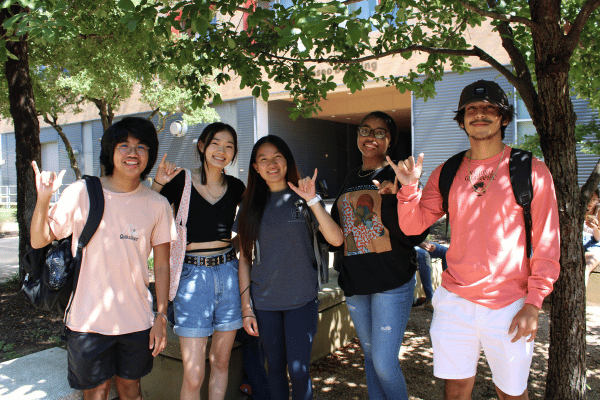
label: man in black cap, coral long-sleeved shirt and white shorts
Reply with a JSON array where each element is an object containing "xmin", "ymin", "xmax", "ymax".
[{"xmin": 388, "ymin": 80, "xmax": 560, "ymax": 400}]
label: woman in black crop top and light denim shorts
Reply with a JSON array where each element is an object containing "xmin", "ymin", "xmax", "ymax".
[{"xmin": 152, "ymin": 122, "xmax": 245, "ymax": 400}]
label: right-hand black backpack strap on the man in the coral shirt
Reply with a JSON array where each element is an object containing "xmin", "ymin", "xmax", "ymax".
[{"xmin": 508, "ymin": 148, "xmax": 533, "ymax": 258}]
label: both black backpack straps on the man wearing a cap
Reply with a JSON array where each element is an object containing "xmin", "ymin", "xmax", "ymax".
[{"xmin": 439, "ymin": 148, "xmax": 533, "ymax": 258}]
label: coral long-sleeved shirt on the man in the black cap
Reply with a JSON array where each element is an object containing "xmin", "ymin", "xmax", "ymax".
[{"xmin": 397, "ymin": 147, "xmax": 560, "ymax": 309}]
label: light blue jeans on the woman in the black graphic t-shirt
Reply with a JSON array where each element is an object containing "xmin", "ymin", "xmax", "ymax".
[{"xmin": 346, "ymin": 277, "xmax": 416, "ymax": 400}]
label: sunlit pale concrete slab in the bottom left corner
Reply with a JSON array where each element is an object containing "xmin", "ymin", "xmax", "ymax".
[{"xmin": 0, "ymin": 347, "xmax": 118, "ymax": 400}]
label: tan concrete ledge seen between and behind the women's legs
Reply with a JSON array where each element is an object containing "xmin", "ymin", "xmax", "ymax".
[{"xmin": 142, "ymin": 266, "xmax": 356, "ymax": 400}]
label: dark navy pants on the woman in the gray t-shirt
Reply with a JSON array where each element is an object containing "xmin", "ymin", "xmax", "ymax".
[{"xmin": 256, "ymin": 299, "xmax": 319, "ymax": 400}]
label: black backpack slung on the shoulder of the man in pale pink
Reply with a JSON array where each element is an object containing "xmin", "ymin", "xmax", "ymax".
[{"xmin": 21, "ymin": 175, "xmax": 104, "ymax": 320}]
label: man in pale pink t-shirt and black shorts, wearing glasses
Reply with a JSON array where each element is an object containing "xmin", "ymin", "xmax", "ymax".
[{"xmin": 31, "ymin": 117, "xmax": 177, "ymax": 400}]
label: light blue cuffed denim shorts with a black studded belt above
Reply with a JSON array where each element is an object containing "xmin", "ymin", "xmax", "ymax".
[{"xmin": 173, "ymin": 253, "xmax": 242, "ymax": 337}]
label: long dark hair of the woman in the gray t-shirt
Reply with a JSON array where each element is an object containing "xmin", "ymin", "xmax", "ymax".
[{"xmin": 238, "ymin": 135, "xmax": 300, "ymax": 260}]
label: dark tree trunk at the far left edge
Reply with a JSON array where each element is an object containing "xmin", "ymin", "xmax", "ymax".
[{"xmin": 0, "ymin": 6, "xmax": 41, "ymax": 279}]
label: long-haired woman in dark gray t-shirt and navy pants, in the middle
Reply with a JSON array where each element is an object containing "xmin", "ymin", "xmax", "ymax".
[{"xmin": 233, "ymin": 135, "xmax": 343, "ymax": 400}]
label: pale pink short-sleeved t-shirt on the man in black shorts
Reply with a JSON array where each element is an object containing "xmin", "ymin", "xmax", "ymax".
[{"xmin": 49, "ymin": 180, "xmax": 177, "ymax": 335}]
